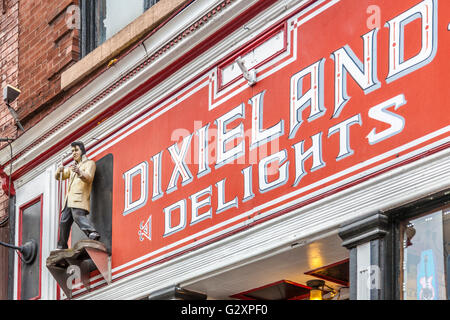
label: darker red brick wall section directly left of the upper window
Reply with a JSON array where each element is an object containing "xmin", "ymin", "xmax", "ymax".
[{"xmin": 17, "ymin": 0, "xmax": 80, "ymax": 129}]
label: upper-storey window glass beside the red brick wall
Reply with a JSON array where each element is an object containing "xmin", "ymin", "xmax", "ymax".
[{"xmin": 80, "ymin": 0, "xmax": 159, "ymax": 57}]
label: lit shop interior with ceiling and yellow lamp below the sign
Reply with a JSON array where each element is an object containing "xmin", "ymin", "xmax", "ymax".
[{"xmin": 180, "ymin": 234, "xmax": 349, "ymax": 300}]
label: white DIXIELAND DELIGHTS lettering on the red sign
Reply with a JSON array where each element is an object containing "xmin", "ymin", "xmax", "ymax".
[{"xmin": 118, "ymin": 0, "xmax": 437, "ymax": 237}]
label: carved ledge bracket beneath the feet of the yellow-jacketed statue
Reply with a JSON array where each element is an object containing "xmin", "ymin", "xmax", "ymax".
[{"xmin": 47, "ymin": 240, "xmax": 111, "ymax": 299}]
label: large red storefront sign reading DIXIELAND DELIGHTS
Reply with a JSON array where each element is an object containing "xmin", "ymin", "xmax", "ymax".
[{"xmin": 86, "ymin": 0, "xmax": 450, "ymax": 277}]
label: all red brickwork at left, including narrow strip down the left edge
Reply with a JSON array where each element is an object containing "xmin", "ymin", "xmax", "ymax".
[{"xmin": 0, "ymin": 0, "xmax": 80, "ymax": 299}]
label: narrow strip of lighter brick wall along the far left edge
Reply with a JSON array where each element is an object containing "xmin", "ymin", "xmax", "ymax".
[{"xmin": 0, "ymin": 0, "xmax": 19, "ymax": 300}]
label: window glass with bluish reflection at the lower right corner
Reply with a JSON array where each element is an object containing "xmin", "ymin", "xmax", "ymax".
[{"xmin": 401, "ymin": 208, "xmax": 450, "ymax": 300}]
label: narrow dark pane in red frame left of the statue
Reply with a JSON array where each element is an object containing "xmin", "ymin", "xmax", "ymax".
[{"xmin": 20, "ymin": 201, "xmax": 41, "ymax": 300}]
